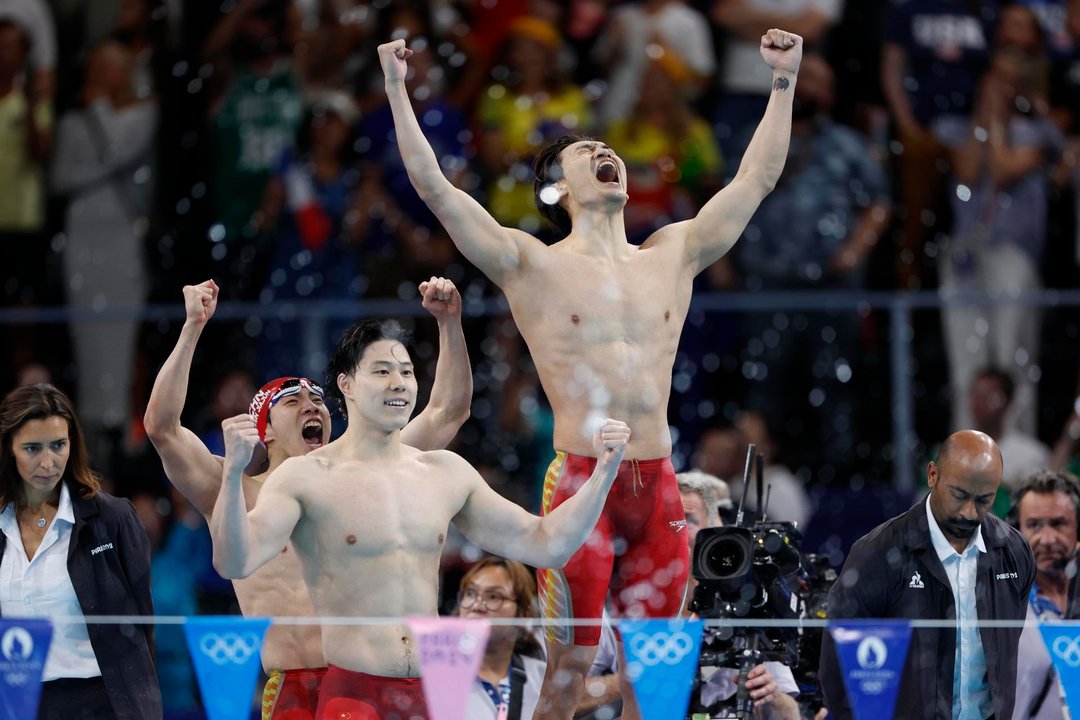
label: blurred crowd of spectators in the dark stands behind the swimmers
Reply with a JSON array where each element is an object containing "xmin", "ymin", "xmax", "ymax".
[{"xmin": 0, "ymin": 0, "xmax": 1080, "ymax": 716}]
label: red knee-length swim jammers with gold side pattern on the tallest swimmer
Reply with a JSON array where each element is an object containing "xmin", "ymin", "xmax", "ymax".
[{"xmin": 537, "ymin": 452, "xmax": 690, "ymax": 646}]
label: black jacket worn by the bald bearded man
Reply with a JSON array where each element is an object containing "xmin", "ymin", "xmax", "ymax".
[{"xmin": 820, "ymin": 501, "xmax": 1036, "ymax": 720}]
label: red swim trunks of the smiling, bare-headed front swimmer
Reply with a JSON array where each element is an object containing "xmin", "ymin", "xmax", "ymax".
[{"xmin": 315, "ymin": 665, "xmax": 428, "ymax": 720}]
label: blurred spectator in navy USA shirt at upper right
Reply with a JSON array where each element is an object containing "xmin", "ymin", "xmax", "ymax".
[{"xmin": 881, "ymin": 0, "xmax": 996, "ymax": 289}]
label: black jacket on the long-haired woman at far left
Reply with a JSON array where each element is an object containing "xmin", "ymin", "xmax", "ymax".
[{"xmin": 0, "ymin": 484, "xmax": 162, "ymax": 720}]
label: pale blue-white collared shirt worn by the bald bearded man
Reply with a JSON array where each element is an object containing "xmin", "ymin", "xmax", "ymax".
[{"xmin": 927, "ymin": 497, "xmax": 994, "ymax": 720}]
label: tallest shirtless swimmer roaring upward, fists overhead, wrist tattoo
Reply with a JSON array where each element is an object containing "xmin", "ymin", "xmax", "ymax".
[{"xmin": 378, "ymin": 29, "xmax": 802, "ymax": 719}]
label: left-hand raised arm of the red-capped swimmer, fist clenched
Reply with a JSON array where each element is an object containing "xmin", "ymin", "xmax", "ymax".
[{"xmin": 143, "ymin": 280, "xmax": 221, "ymax": 516}]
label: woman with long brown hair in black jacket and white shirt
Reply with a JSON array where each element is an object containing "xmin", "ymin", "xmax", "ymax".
[{"xmin": 0, "ymin": 384, "xmax": 162, "ymax": 720}]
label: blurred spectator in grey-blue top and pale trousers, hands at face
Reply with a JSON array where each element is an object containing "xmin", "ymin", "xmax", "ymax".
[{"xmin": 934, "ymin": 38, "xmax": 1063, "ymax": 434}]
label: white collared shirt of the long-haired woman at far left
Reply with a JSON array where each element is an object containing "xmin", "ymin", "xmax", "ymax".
[{"xmin": 0, "ymin": 483, "xmax": 102, "ymax": 681}]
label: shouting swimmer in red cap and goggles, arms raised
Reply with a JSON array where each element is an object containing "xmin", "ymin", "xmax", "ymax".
[{"xmin": 145, "ymin": 277, "xmax": 472, "ymax": 720}]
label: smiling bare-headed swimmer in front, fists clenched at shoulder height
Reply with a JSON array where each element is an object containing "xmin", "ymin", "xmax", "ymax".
[{"xmin": 211, "ymin": 321, "xmax": 630, "ymax": 719}]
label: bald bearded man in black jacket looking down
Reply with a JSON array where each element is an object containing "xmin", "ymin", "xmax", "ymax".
[{"xmin": 820, "ymin": 430, "xmax": 1036, "ymax": 720}]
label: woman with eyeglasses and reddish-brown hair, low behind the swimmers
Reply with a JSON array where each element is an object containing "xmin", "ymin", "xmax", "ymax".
[{"xmin": 458, "ymin": 557, "xmax": 546, "ymax": 720}]
